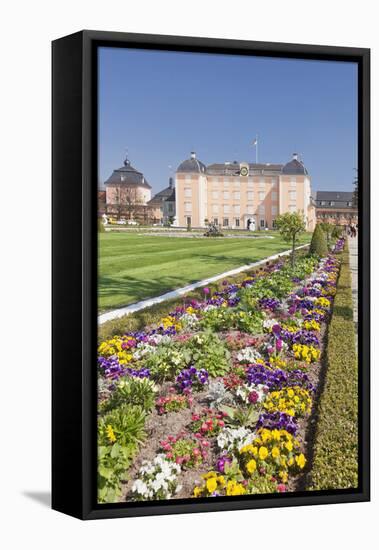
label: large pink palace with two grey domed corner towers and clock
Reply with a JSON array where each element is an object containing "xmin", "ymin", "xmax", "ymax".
[{"xmin": 175, "ymin": 152, "xmax": 316, "ymax": 231}]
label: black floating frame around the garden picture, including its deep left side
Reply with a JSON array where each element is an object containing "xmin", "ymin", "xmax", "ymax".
[{"xmin": 52, "ymin": 31, "xmax": 370, "ymax": 519}]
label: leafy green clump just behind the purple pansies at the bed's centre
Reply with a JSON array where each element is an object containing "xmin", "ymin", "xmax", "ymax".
[{"xmin": 183, "ymin": 330, "xmax": 231, "ymax": 377}]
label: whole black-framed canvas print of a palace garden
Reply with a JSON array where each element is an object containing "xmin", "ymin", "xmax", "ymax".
[{"xmin": 52, "ymin": 31, "xmax": 370, "ymax": 519}]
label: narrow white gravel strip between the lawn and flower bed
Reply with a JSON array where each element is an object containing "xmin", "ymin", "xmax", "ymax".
[{"xmin": 97, "ymin": 244, "xmax": 309, "ymax": 325}]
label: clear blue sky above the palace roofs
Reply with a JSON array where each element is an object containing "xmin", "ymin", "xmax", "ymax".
[{"xmin": 99, "ymin": 48, "xmax": 357, "ymax": 193}]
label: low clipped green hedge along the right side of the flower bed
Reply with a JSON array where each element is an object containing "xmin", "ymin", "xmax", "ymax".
[{"xmin": 307, "ymin": 241, "xmax": 358, "ymax": 490}]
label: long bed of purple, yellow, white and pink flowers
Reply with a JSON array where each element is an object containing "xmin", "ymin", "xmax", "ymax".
[{"xmin": 98, "ymin": 242, "xmax": 341, "ymax": 502}]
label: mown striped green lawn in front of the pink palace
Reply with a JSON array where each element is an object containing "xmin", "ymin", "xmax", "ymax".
[{"xmin": 99, "ymin": 233, "xmax": 311, "ymax": 311}]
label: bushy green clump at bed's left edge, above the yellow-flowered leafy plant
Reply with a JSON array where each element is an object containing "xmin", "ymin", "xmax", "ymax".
[{"xmin": 101, "ymin": 376, "xmax": 157, "ymax": 413}]
